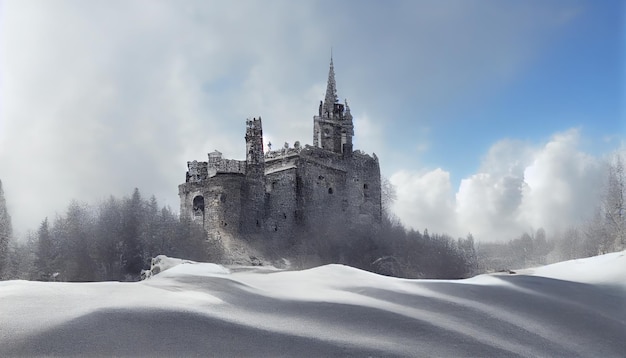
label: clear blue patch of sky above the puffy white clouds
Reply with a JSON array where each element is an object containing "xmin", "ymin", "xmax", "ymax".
[{"xmin": 376, "ymin": 2, "xmax": 625, "ymax": 181}]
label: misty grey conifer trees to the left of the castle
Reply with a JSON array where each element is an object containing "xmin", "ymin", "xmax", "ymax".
[{"xmin": 0, "ymin": 189, "xmax": 221, "ymax": 281}]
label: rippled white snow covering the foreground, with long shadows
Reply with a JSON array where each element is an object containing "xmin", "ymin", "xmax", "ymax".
[{"xmin": 0, "ymin": 252, "xmax": 626, "ymax": 357}]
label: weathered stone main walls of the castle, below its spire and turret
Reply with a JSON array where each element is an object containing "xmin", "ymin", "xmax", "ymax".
[{"xmin": 179, "ymin": 146, "xmax": 382, "ymax": 249}]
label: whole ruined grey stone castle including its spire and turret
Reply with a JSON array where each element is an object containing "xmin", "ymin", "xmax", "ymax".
[{"xmin": 178, "ymin": 57, "xmax": 381, "ymax": 248}]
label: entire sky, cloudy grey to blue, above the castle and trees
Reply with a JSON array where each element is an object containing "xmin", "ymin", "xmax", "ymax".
[{"xmin": 0, "ymin": 0, "xmax": 626, "ymax": 240}]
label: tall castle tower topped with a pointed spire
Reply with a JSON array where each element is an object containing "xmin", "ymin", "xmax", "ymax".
[{"xmin": 313, "ymin": 56, "xmax": 354, "ymax": 156}]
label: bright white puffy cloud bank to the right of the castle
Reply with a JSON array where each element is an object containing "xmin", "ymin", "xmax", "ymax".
[{"xmin": 390, "ymin": 129, "xmax": 606, "ymax": 241}]
